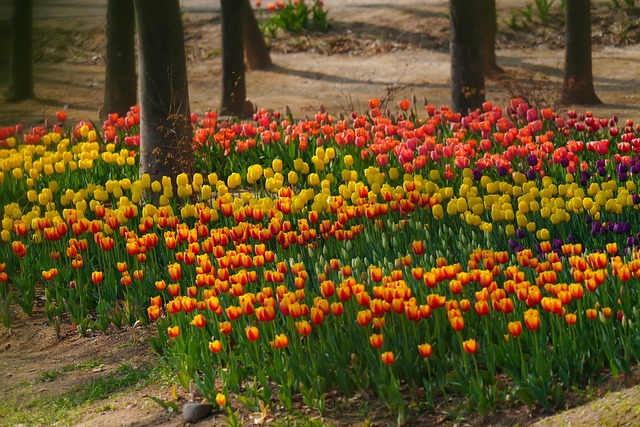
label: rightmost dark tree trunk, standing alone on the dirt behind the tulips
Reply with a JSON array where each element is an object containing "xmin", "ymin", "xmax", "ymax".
[{"xmin": 562, "ymin": 0, "xmax": 601, "ymax": 104}]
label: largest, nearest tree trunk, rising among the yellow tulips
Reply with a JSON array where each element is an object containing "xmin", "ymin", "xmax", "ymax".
[{"xmin": 134, "ymin": 0, "xmax": 194, "ymax": 187}]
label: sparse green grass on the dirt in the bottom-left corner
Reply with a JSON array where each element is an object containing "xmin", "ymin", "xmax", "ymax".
[{"xmin": 0, "ymin": 363, "xmax": 154, "ymax": 427}]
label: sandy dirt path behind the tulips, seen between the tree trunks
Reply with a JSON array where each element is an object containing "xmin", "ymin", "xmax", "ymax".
[{"xmin": 0, "ymin": 0, "xmax": 640, "ymax": 125}]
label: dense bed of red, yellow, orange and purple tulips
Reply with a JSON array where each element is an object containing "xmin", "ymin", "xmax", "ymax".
[{"xmin": 0, "ymin": 99, "xmax": 640, "ymax": 420}]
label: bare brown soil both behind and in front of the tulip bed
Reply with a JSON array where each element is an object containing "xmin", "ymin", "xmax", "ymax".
[{"xmin": 0, "ymin": 0, "xmax": 640, "ymax": 427}]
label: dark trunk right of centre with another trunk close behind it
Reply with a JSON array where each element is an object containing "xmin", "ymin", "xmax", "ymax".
[{"xmin": 449, "ymin": 0, "xmax": 485, "ymax": 114}]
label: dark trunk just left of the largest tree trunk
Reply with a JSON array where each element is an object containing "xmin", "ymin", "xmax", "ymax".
[{"xmin": 102, "ymin": 0, "xmax": 137, "ymax": 117}]
